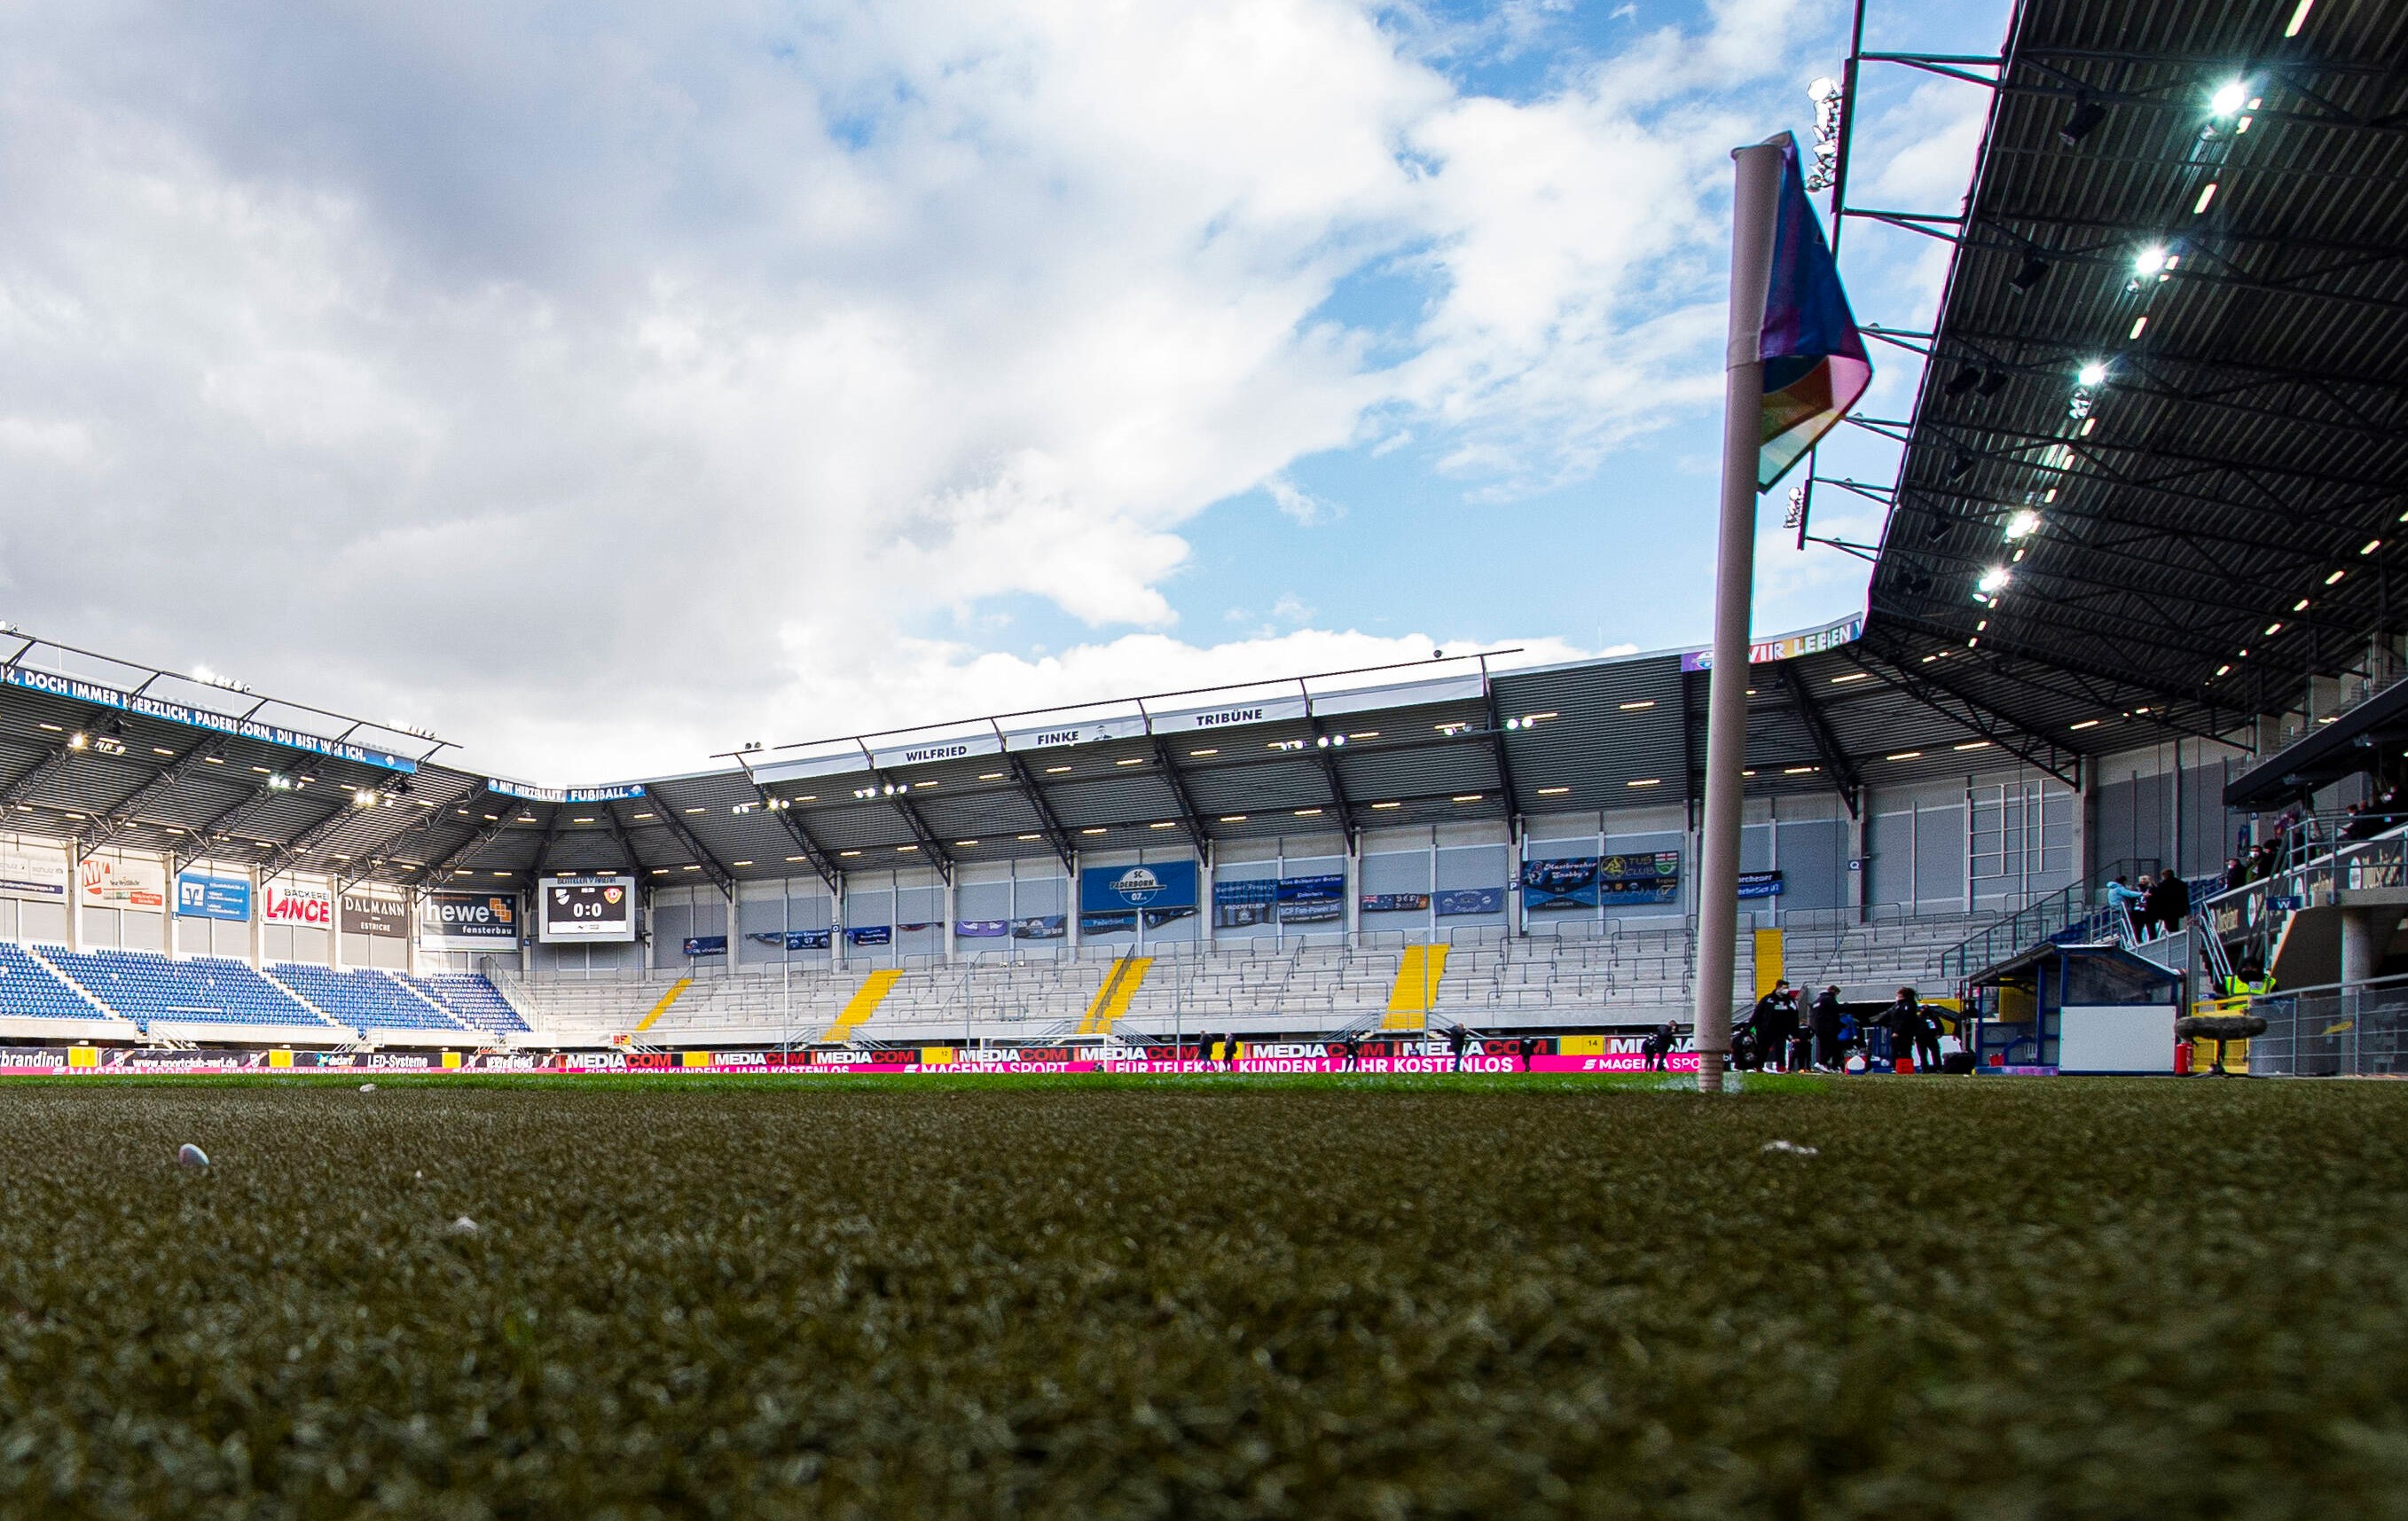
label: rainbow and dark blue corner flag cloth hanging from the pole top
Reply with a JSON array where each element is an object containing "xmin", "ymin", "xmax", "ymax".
[{"xmin": 1755, "ymin": 132, "xmax": 1873, "ymax": 491}]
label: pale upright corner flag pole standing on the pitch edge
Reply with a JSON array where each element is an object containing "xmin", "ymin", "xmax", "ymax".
[{"xmin": 1693, "ymin": 139, "xmax": 1782, "ymax": 1093}]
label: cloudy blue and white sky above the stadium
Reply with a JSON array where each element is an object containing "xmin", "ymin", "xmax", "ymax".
[{"xmin": 0, "ymin": 0, "xmax": 2006, "ymax": 785}]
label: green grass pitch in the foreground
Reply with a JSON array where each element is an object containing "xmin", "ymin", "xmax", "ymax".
[{"xmin": 0, "ymin": 1078, "xmax": 2408, "ymax": 1521}]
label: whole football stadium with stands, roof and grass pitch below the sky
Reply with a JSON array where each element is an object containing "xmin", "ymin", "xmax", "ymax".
[{"xmin": 0, "ymin": 0, "xmax": 2408, "ymax": 1518}]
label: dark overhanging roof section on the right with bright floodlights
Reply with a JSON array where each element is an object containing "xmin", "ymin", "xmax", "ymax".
[{"xmin": 1849, "ymin": 0, "xmax": 2408, "ymax": 753}]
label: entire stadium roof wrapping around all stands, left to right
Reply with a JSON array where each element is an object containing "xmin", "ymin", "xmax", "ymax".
[{"xmin": 0, "ymin": 0, "xmax": 2408, "ymax": 888}]
